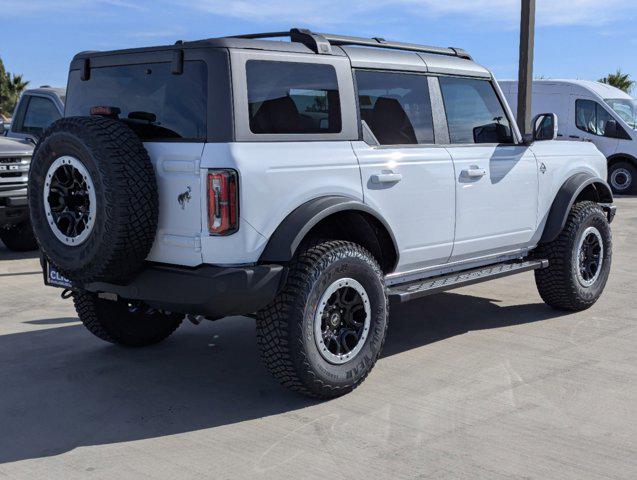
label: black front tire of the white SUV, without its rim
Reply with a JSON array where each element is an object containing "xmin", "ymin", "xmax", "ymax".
[{"xmin": 535, "ymin": 201, "xmax": 613, "ymax": 312}]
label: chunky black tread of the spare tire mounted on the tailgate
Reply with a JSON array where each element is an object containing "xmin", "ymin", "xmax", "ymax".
[{"xmin": 30, "ymin": 117, "xmax": 159, "ymax": 282}]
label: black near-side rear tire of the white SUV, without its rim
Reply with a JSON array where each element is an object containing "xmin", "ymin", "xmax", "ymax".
[{"xmin": 257, "ymin": 241, "xmax": 389, "ymax": 399}]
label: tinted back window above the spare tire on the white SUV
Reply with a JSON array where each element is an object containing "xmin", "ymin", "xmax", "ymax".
[{"xmin": 65, "ymin": 61, "xmax": 207, "ymax": 140}]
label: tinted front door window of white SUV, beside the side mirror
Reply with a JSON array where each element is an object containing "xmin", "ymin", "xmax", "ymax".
[{"xmin": 440, "ymin": 77, "xmax": 513, "ymax": 143}]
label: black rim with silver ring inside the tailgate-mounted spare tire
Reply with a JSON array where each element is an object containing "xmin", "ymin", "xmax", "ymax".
[{"xmin": 43, "ymin": 155, "xmax": 97, "ymax": 246}]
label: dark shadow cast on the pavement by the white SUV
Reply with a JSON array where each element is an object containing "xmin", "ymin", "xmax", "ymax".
[{"xmin": 0, "ymin": 293, "xmax": 559, "ymax": 463}]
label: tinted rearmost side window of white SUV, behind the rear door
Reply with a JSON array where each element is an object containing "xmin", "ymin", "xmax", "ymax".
[{"xmin": 246, "ymin": 60, "xmax": 341, "ymax": 134}]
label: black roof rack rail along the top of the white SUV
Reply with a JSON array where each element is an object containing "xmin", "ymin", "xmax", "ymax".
[{"xmin": 228, "ymin": 28, "xmax": 472, "ymax": 60}]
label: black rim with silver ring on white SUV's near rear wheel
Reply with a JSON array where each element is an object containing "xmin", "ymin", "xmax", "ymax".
[{"xmin": 314, "ymin": 278, "xmax": 372, "ymax": 365}]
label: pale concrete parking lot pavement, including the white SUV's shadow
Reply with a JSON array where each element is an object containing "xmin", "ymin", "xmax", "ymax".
[{"xmin": 0, "ymin": 198, "xmax": 637, "ymax": 480}]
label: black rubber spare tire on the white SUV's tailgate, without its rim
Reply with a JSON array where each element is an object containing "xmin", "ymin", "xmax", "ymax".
[{"xmin": 29, "ymin": 117, "xmax": 159, "ymax": 283}]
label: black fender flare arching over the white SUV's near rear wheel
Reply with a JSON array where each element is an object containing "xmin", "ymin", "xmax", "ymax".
[{"xmin": 259, "ymin": 195, "xmax": 399, "ymax": 263}]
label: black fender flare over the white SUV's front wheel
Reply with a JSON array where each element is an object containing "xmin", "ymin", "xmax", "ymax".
[{"xmin": 540, "ymin": 172, "xmax": 613, "ymax": 243}]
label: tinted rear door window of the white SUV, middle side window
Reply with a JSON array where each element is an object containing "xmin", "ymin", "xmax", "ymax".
[{"xmin": 356, "ymin": 71, "xmax": 434, "ymax": 145}]
